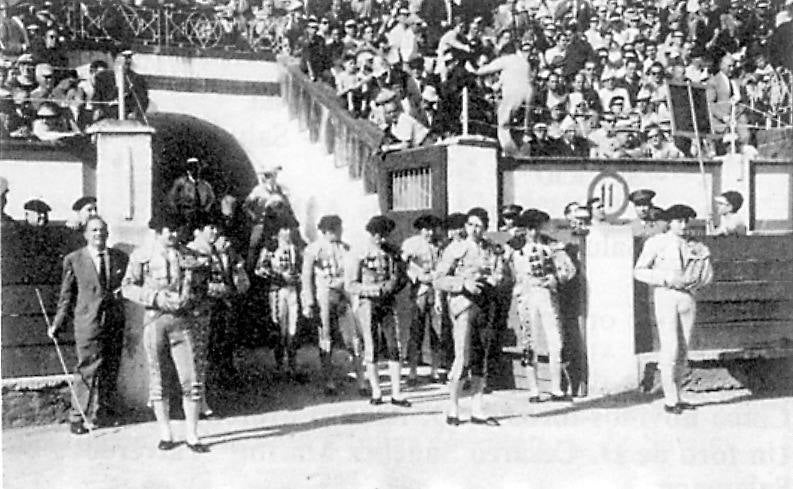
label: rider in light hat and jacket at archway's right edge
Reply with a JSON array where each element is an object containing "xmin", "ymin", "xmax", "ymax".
[{"xmin": 242, "ymin": 164, "xmax": 298, "ymax": 270}]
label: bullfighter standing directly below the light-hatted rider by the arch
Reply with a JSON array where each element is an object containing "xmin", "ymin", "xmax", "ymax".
[{"xmin": 255, "ymin": 215, "xmax": 303, "ymax": 380}]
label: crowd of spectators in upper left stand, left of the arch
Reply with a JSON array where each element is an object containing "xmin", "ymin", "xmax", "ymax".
[{"xmin": 0, "ymin": 2, "xmax": 148, "ymax": 141}]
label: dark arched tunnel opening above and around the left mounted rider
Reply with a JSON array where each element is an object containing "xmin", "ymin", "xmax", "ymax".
[{"xmin": 147, "ymin": 112, "xmax": 256, "ymax": 212}]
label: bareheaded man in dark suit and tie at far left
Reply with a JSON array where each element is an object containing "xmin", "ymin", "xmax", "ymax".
[{"xmin": 47, "ymin": 216, "xmax": 127, "ymax": 435}]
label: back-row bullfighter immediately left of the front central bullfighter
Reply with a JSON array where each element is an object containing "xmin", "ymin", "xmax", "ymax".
[{"xmin": 402, "ymin": 214, "xmax": 443, "ymax": 385}]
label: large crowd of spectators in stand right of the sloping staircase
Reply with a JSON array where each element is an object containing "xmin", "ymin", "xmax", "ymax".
[{"xmin": 283, "ymin": 0, "xmax": 793, "ymax": 158}]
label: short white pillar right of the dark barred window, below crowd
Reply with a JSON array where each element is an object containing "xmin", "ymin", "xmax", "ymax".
[{"xmin": 446, "ymin": 139, "xmax": 499, "ymax": 230}]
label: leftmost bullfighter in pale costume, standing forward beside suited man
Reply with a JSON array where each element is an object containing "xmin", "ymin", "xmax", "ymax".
[{"xmin": 121, "ymin": 215, "xmax": 209, "ymax": 453}]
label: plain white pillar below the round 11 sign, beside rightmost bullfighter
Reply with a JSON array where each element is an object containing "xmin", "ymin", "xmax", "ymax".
[{"xmin": 586, "ymin": 226, "xmax": 638, "ymax": 397}]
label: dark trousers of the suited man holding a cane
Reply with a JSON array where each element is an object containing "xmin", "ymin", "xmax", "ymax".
[{"xmin": 69, "ymin": 325, "xmax": 123, "ymax": 423}]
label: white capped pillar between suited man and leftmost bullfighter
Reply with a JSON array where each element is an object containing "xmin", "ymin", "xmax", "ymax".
[{"xmin": 88, "ymin": 119, "xmax": 154, "ymax": 409}]
